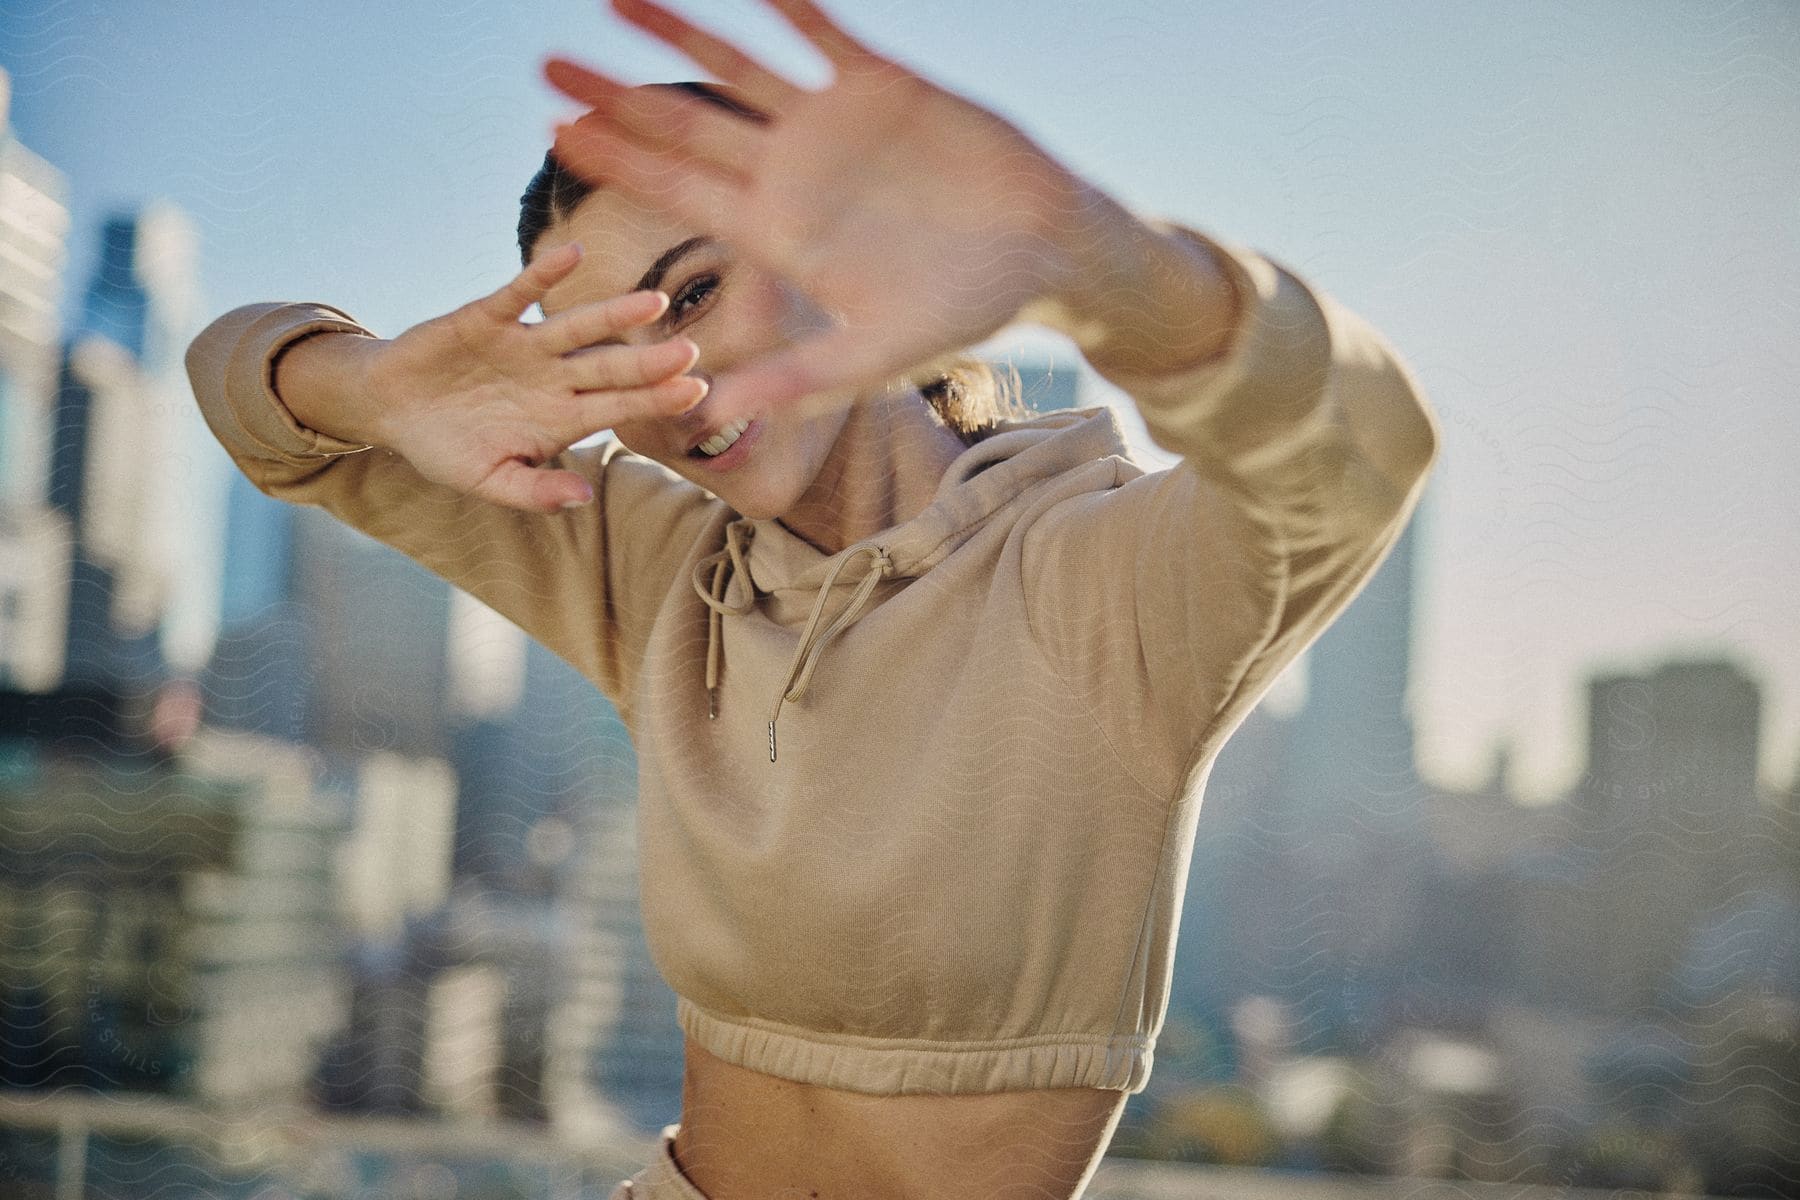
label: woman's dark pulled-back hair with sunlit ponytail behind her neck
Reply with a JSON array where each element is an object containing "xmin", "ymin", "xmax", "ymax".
[{"xmin": 518, "ymin": 81, "xmax": 1033, "ymax": 446}]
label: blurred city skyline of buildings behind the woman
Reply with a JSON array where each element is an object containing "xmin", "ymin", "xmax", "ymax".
[{"xmin": 0, "ymin": 21, "xmax": 1800, "ymax": 1200}]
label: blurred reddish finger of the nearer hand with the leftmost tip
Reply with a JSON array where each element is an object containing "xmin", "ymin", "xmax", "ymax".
[{"xmin": 544, "ymin": 58, "xmax": 767, "ymax": 178}]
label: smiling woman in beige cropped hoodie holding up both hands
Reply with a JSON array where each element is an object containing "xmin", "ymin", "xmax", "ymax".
[{"xmin": 189, "ymin": 0, "xmax": 1436, "ymax": 1200}]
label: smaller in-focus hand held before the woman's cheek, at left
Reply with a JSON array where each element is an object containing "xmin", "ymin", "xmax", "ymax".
[{"xmin": 338, "ymin": 245, "xmax": 706, "ymax": 513}]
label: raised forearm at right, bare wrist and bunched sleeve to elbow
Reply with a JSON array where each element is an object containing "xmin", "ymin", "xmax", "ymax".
[{"xmin": 1022, "ymin": 180, "xmax": 1438, "ymax": 495}]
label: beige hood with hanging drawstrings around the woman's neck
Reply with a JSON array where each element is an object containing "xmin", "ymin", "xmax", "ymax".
[{"xmin": 693, "ymin": 407, "xmax": 1130, "ymax": 761}]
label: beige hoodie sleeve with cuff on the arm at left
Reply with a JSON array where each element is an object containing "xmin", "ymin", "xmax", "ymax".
[{"xmin": 187, "ymin": 304, "xmax": 716, "ymax": 709}]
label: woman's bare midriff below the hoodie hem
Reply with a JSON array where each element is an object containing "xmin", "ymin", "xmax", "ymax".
[{"xmin": 675, "ymin": 1042, "xmax": 1127, "ymax": 1200}]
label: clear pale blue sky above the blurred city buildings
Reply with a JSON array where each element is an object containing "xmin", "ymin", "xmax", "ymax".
[{"xmin": 0, "ymin": 0, "xmax": 1800, "ymax": 795}]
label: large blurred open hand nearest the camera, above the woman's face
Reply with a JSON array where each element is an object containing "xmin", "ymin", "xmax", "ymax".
[{"xmin": 545, "ymin": 0, "xmax": 1096, "ymax": 426}]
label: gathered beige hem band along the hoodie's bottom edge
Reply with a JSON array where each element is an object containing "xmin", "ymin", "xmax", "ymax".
[{"xmin": 675, "ymin": 997, "xmax": 1154, "ymax": 1096}]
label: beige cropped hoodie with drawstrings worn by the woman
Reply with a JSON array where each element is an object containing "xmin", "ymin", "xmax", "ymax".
[{"xmin": 187, "ymin": 223, "xmax": 1438, "ymax": 1094}]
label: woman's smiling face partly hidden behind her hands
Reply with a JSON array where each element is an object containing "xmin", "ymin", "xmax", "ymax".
[{"xmin": 533, "ymin": 189, "xmax": 850, "ymax": 520}]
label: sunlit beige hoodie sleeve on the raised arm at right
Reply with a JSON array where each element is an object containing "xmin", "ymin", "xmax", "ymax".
[{"xmin": 1021, "ymin": 223, "xmax": 1438, "ymax": 793}]
